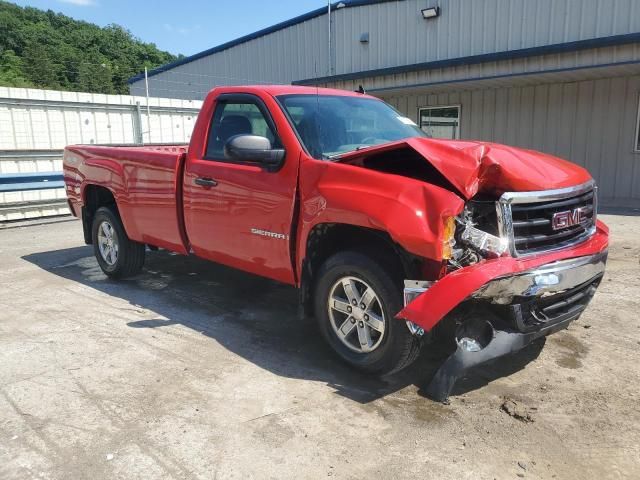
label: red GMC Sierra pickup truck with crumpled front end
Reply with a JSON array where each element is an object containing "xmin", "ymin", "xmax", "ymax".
[{"xmin": 64, "ymin": 86, "xmax": 608, "ymax": 400}]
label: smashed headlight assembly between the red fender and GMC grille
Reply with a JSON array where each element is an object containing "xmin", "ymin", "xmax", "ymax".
[{"xmin": 450, "ymin": 199, "xmax": 508, "ymax": 268}]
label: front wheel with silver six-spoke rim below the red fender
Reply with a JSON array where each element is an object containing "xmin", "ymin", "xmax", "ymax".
[{"xmin": 314, "ymin": 252, "xmax": 420, "ymax": 375}]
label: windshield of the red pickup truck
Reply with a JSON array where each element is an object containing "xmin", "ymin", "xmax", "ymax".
[{"xmin": 278, "ymin": 95, "xmax": 427, "ymax": 159}]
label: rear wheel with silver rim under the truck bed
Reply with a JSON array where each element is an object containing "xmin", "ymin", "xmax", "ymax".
[{"xmin": 91, "ymin": 207, "xmax": 145, "ymax": 278}]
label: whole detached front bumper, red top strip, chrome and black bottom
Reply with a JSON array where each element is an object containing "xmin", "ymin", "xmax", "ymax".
[{"xmin": 398, "ymin": 222, "xmax": 608, "ymax": 401}]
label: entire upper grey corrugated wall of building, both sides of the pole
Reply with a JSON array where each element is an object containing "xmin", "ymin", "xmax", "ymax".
[{"xmin": 131, "ymin": 0, "xmax": 640, "ymax": 99}]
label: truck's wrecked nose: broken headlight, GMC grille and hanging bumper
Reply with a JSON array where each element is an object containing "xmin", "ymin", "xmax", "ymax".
[{"xmin": 398, "ymin": 183, "xmax": 608, "ymax": 401}]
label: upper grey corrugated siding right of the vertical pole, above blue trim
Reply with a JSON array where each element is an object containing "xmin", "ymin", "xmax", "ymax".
[{"xmin": 334, "ymin": 0, "xmax": 640, "ymax": 74}]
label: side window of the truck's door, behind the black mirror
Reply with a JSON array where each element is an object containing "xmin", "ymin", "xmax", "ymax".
[{"xmin": 206, "ymin": 102, "xmax": 279, "ymax": 159}]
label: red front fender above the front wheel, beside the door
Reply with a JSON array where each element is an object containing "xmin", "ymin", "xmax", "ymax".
[{"xmin": 298, "ymin": 160, "xmax": 464, "ymax": 265}]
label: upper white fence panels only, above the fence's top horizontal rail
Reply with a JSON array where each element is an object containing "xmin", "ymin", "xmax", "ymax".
[{"xmin": 0, "ymin": 87, "xmax": 202, "ymax": 150}]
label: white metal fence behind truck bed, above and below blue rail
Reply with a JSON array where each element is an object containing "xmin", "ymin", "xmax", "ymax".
[{"xmin": 0, "ymin": 87, "xmax": 202, "ymax": 221}]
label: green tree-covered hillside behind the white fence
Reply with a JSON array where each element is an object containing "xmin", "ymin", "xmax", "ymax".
[{"xmin": 0, "ymin": 0, "xmax": 178, "ymax": 94}]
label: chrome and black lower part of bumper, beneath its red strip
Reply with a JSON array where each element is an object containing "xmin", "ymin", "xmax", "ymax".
[{"xmin": 426, "ymin": 250, "xmax": 607, "ymax": 401}]
